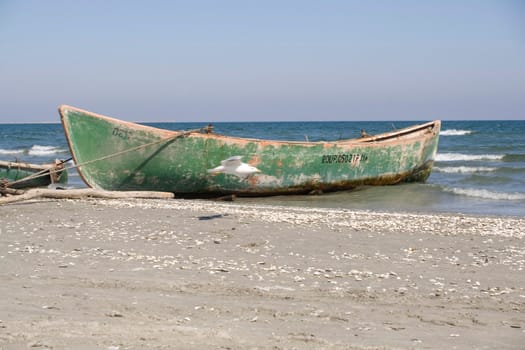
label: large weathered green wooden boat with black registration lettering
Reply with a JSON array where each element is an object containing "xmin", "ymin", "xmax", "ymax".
[{"xmin": 59, "ymin": 105, "xmax": 441, "ymax": 196}]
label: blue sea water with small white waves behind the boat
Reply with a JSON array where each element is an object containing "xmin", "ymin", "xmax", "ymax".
[{"xmin": 0, "ymin": 121, "xmax": 525, "ymax": 217}]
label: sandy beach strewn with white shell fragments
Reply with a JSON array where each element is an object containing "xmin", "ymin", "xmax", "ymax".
[{"xmin": 0, "ymin": 199, "xmax": 525, "ymax": 350}]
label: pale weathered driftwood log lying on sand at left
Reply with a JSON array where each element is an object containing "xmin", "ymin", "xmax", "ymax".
[{"xmin": 0, "ymin": 188, "xmax": 175, "ymax": 205}]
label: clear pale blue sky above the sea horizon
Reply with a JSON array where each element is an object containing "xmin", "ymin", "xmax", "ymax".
[{"xmin": 0, "ymin": 0, "xmax": 525, "ymax": 122}]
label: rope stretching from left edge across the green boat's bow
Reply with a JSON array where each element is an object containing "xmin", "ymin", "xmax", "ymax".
[{"xmin": 0, "ymin": 124, "xmax": 213, "ymax": 188}]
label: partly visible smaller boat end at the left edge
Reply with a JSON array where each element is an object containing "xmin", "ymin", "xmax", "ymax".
[{"xmin": 0, "ymin": 160, "xmax": 68, "ymax": 189}]
